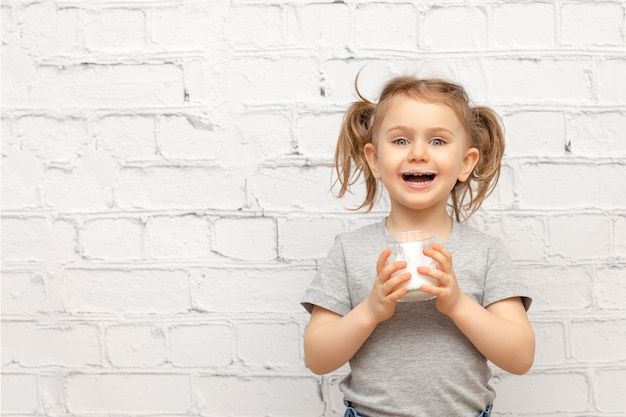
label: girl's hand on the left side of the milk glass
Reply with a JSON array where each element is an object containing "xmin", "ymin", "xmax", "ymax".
[{"xmin": 364, "ymin": 248, "xmax": 411, "ymax": 323}]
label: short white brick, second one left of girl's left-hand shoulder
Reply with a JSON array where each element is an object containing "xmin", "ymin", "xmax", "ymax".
[{"xmin": 213, "ymin": 218, "xmax": 277, "ymax": 261}]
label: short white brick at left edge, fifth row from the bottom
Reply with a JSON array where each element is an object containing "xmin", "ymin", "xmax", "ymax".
[{"xmin": 2, "ymin": 151, "xmax": 44, "ymax": 209}]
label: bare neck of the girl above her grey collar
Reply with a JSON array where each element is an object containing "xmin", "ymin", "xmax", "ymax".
[{"xmin": 385, "ymin": 203, "xmax": 452, "ymax": 242}]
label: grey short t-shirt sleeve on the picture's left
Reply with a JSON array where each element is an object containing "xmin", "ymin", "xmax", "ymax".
[{"xmin": 301, "ymin": 237, "xmax": 352, "ymax": 316}]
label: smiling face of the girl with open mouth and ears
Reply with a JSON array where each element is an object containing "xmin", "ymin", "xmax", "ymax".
[{"xmin": 365, "ymin": 96, "xmax": 478, "ymax": 216}]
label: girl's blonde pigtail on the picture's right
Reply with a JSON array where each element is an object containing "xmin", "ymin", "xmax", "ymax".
[{"xmin": 452, "ymin": 106, "xmax": 505, "ymax": 221}]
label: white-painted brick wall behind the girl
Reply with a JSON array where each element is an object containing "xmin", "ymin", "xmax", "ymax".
[{"xmin": 1, "ymin": 0, "xmax": 626, "ymax": 417}]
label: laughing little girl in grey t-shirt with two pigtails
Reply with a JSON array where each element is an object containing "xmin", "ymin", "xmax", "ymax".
[{"xmin": 302, "ymin": 77, "xmax": 535, "ymax": 417}]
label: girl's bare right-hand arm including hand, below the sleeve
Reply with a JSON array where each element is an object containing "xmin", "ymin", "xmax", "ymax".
[{"xmin": 418, "ymin": 240, "xmax": 535, "ymax": 374}]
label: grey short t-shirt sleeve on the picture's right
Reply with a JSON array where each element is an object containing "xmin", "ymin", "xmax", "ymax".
[{"xmin": 482, "ymin": 239, "xmax": 532, "ymax": 311}]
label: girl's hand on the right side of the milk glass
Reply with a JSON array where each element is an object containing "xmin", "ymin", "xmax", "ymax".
[{"xmin": 417, "ymin": 243, "xmax": 463, "ymax": 315}]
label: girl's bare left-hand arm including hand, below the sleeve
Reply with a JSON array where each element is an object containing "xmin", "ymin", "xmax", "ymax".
[{"xmin": 304, "ymin": 249, "xmax": 411, "ymax": 375}]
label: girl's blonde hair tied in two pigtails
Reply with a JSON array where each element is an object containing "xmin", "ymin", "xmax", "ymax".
[{"xmin": 333, "ymin": 75, "xmax": 504, "ymax": 221}]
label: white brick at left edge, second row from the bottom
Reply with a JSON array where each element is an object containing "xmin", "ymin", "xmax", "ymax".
[{"xmin": 2, "ymin": 321, "xmax": 102, "ymax": 367}]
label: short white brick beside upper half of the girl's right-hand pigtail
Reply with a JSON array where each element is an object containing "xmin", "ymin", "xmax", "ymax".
[{"xmin": 503, "ymin": 111, "xmax": 571, "ymax": 157}]
